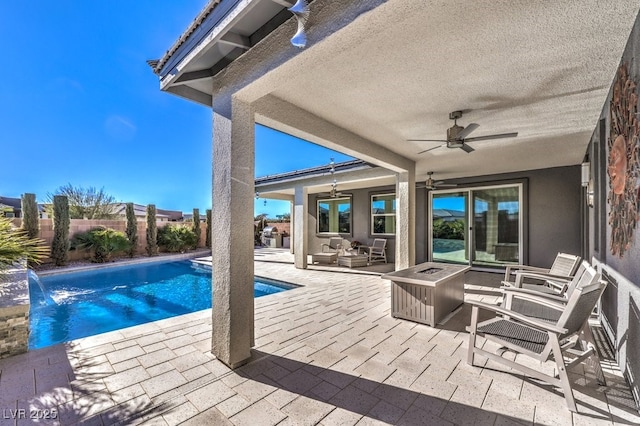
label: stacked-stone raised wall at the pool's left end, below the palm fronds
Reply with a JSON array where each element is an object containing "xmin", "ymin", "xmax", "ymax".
[{"xmin": 0, "ymin": 268, "xmax": 29, "ymax": 359}]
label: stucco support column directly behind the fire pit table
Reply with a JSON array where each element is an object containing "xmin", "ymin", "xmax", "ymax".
[{"xmin": 396, "ymin": 169, "xmax": 416, "ymax": 270}]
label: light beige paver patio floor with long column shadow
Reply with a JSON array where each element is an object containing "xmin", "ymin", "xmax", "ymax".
[{"xmin": 0, "ymin": 255, "xmax": 640, "ymax": 425}]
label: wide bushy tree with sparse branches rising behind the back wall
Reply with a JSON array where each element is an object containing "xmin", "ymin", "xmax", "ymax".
[{"xmin": 48, "ymin": 183, "xmax": 116, "ymax": 219}]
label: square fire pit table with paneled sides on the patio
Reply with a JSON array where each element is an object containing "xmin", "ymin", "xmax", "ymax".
[{"xmin": 382, "ymin": 262, "xmax": 471, "ymax": 327}]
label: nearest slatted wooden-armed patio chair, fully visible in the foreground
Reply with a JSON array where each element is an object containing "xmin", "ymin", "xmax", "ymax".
[{"xmin": 467, "ymin": 268, "xmax": 607, "ymax": 412}]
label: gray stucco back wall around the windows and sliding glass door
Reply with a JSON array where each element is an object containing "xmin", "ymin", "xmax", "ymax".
[{"xmin": 307, "ymin": 165, "xmax": 582, "ymax": 267}]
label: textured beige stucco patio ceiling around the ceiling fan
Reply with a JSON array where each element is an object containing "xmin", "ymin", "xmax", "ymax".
[{"xmin": 156, "ymin": 0, "xmax": 639, "ymax": 186}]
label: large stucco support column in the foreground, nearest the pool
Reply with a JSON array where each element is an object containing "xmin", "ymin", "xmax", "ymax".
[{"xmin": 211, "ymin": 100, "xmax": 255, "ymax": 368}]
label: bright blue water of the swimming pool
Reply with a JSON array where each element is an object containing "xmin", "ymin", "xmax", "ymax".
[{"xmin": 29, "ymin": 261, "xmax": 295, "ymax": 349}]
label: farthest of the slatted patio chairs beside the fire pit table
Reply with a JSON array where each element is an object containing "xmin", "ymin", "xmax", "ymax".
[{"xmin": 502, "ymin": 253, "xmax": 581, "ymax": 293}]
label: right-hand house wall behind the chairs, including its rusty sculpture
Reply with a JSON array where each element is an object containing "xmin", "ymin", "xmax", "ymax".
[{"xmin": 587, "ymin": 9, "xmax": 640, "ymax": 401}]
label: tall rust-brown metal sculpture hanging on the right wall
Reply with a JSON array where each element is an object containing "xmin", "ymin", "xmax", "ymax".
[{"xmin": 607, "ymin": 63, "xmax": 640, "ymax": 258}]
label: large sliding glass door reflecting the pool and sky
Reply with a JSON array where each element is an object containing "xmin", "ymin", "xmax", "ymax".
[{"xmin": 429, "ymin": 184, "xmax": 523, "ymax": 267}]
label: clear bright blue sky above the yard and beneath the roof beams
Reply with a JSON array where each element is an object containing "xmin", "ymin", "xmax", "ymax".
[{"xmin": 0, "ymin": 0, "xmax": 349, "ymax": 217}]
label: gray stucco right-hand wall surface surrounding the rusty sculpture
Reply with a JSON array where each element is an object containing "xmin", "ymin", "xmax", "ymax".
[{"xmin": 588, "ymin": 9, "xmax": 640, "ymax": 402}]
